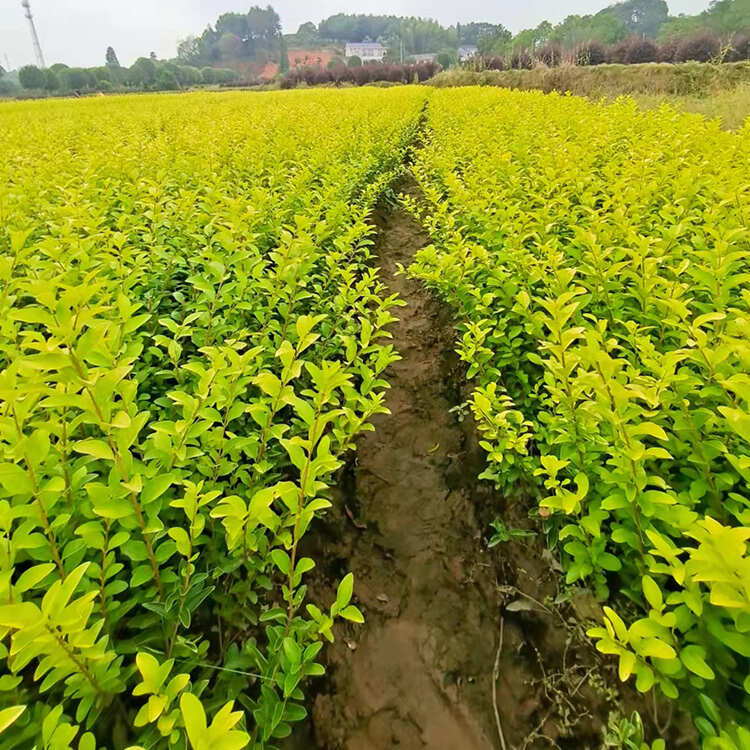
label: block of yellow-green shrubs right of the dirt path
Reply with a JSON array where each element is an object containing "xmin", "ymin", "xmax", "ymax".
[{"xmin": 410, "ymin": 89, "xmax": 750, "ymax": 750}]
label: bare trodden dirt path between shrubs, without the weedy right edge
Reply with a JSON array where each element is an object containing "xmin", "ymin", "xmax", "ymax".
[{"xmin": 302, "ymin": 191, "xmax": 506, "ymax": 750}]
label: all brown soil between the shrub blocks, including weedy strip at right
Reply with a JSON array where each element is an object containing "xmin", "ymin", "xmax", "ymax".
[{"xmin": 294, "ymin": 184, "xmax": 688, "ymax": 750}]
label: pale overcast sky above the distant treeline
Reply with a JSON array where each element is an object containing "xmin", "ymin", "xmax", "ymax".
[{"xmin": 0, "ymin": 0, "xmax": 708, "ymax": 68}]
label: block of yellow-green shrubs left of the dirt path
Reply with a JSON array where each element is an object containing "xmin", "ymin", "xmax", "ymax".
[{"xmin": 0, "ymin": 88, "xmax": 423, "ymax": 750}]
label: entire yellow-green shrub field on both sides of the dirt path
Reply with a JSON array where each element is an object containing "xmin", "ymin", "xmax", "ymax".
[{"xmin": 0, "ymin": 86, "xmax": 750, "ymax": 750}]
